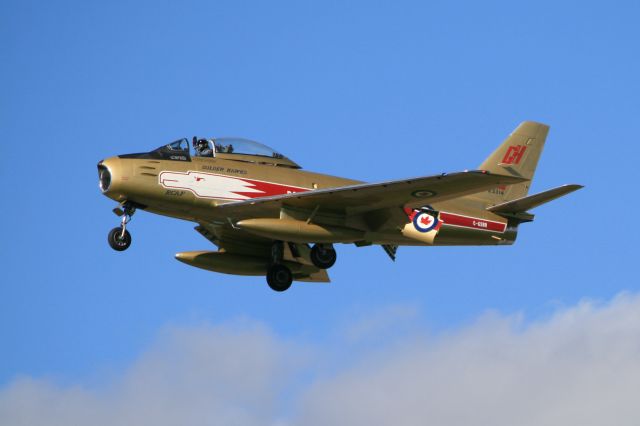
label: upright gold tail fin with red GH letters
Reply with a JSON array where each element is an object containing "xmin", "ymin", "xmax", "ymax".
[{"xmin": 476, "ymin": 121, "xmax": 549, "ymax": 204}]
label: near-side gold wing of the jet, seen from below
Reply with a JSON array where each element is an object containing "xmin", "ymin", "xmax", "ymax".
[{"xmin": 217, "ymin": 171, "xmax": 527, "ymax": 218}]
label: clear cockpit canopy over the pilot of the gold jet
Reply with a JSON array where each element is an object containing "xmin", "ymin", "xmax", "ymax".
[{"xmin": 152, "ymin": 137, "xmax": 300, "ymax": 168}]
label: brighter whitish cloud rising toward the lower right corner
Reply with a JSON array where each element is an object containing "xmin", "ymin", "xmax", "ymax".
[{"xmin": 299, "ymin": 296, "xmax": 640, "ymax": 426}]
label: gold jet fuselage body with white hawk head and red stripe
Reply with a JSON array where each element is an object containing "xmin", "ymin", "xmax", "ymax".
[{"xmin": 101, "ymin": 152, "xmax": 517, "ymax": 246}]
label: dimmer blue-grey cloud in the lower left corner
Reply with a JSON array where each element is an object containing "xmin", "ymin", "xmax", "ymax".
[{"xmin": 0, "ymin": 324, "xmax": 307, "ymax": 426}]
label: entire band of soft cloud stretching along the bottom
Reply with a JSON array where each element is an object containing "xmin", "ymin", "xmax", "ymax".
[{"xmin": 0, "ymin": 294, "xmax": 640, "ymax": 426}]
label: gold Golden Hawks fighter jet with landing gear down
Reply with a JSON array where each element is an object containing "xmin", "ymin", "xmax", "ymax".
[{"xmin": 98, "ymin": 121, "xmax": 582, "ymax": 291}]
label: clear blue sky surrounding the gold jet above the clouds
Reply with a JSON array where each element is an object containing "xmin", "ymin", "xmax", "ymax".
[{"xmin": 0, "ymin": 1, "xmax": 640, "ymax": 422}]
